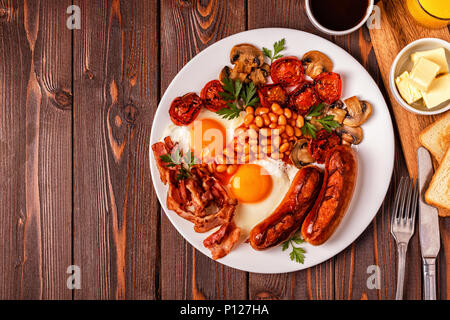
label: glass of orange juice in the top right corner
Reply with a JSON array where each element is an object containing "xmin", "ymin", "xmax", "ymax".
[{"xmin": 406, "ymin": 0, "xmax": 450, "ymax": 29}]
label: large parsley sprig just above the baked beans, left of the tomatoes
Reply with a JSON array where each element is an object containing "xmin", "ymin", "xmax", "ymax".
[{"xmin": 216, "ymin": 78, "xmax": 259, "ymax": 120}]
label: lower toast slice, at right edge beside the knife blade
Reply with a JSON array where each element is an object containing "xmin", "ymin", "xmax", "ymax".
[{"xmin": 425, "ymin": 149, "xmax": 450, "ymax": 210}]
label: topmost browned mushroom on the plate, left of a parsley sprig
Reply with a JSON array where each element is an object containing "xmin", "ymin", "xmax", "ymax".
[{"xmin": 230, "ymin": 43, "xmax": 264, "ymax": 74}]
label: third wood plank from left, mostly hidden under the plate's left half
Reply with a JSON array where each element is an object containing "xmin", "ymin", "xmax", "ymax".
[{"xmin": 161, "ymin": 0, "xmax": 247, "ymax": 299}]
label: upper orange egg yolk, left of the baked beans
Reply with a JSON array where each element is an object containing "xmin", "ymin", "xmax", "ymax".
[{"xmin": 190, "ymin": 118, "xmax": 226, "ymax": 159}]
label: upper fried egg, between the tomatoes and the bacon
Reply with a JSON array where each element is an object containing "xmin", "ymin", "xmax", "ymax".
[{"xmin": 163, "ymin": 109, "xmax": 245, "ymax": 159}]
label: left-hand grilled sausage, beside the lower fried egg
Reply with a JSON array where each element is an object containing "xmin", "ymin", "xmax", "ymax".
[{"xmin": 249, "ymin": 166, "xmax": 322, "ymax": 250}]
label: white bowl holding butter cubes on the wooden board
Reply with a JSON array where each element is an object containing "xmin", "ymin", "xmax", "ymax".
[{"xmin": 389, "ymin": 38, "xmax": 450, "ymax": 115}]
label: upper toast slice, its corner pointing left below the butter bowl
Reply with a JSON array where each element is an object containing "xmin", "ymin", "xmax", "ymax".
[{"xmin": 419, "ymin": 111, "xmax": 450, "ymax": 163}]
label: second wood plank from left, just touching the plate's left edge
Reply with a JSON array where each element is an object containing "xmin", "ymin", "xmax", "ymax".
[{"xmin": 74, "ymin": 0, "xmax": 159, "ymax": 299}]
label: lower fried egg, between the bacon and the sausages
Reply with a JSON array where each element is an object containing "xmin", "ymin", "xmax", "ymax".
[{"xmin": 229, "ymin": 158, "xmax": 298, "ymax": 238}]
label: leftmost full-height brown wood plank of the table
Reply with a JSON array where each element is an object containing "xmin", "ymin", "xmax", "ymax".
[{"xmin": 0, "ymin": 0, "xmax": 72, "ymax": 299}]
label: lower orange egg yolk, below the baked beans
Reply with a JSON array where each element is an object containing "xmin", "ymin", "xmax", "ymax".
[{"xmin": 230, "ymin": 164, "xmax": 272, "ymax": 202}]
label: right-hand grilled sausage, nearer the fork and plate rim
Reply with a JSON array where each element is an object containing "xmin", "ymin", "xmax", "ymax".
[{"xmin": 301, "ymin": 146, "xmax": 358, "ymax": 245}]
